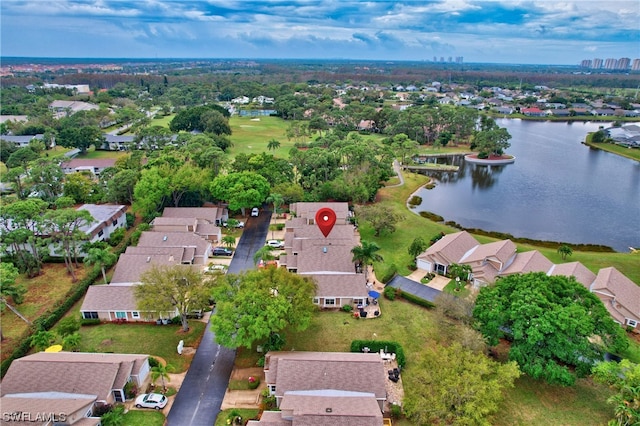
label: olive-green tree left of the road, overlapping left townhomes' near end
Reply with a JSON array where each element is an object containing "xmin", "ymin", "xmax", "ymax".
[{"xmin": 134, "ymin": 265, "xmax": 211, "ymax": 331}]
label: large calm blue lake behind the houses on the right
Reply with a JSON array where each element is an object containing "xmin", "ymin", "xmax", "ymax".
[{"xmin": 416, "ymin": 119, "xmax": 640, "ymax": 251}]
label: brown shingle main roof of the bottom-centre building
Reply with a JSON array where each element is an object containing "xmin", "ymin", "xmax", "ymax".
[{"xmin": 265, "ymin": 352, "xmax": 386, "ymax": 399}]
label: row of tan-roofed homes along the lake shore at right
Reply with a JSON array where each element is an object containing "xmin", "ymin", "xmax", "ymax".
[{"xmin": 416, "ymin": 231, "xmax": 640, "ymax": 328}]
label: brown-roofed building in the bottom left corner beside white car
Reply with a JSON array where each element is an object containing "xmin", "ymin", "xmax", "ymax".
[{"xmin": 0, "ymin": 352, "xmax": 151, "ymax": 426}]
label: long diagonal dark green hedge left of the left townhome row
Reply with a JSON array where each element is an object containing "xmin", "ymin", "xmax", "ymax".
[{"xmin": 0, "ymin": 233, "xmax": 128, "ymax": 377}]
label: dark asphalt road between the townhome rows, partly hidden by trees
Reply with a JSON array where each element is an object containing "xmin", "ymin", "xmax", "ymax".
[{"xmin": 167, "ymin": 210, "xmax": 271, "ymax": 426}]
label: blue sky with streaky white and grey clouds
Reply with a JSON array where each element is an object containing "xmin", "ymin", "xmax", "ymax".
[{"xmin": 0, "ymin": 0, "xmax": 640, "ymax": 65}]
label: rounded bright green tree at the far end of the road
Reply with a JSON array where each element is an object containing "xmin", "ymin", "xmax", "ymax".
[{"xmin": 209, "ymin": 172, "xmax": 270, "ymax": 214}]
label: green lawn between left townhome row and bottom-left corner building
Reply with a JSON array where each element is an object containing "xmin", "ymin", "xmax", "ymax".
[{"xmin": 78, "ymin": 320, "xmax": 206, "ymax": 373}]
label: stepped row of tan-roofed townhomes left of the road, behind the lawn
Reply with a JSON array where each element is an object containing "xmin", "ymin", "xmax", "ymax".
[{"xmin": 80, "ymin": 207, "xmax": 229, "ymax": 322}]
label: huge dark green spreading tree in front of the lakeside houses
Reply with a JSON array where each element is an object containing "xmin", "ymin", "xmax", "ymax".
[{"xmin": 473, "ymin": 272, "xmax": 628, "ymax": 385}]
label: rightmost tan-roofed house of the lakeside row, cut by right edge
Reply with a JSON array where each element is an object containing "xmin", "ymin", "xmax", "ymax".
[{"xmin": 589, "ymin": 267, "xmax": 640, "ymax": 330}]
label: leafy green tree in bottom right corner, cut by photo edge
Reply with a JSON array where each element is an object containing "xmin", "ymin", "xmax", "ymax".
[{"xmin": 593, "ymin": 359, "xmax": 640, "ymax": 426}]
